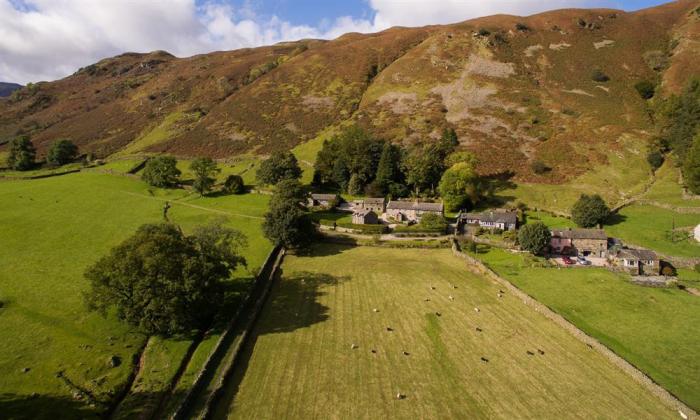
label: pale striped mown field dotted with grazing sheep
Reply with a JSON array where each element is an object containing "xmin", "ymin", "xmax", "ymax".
[{"xmin": 216, "ymin": 245, "xmax": 674, "ymax": 419}]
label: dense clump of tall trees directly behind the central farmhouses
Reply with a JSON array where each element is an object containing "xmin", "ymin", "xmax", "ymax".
[{"xmin": 313, "ymin": 126, "xmax": 490, "ymax": 210}]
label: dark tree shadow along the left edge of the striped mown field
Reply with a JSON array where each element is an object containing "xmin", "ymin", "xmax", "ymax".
[{"xmin": 212, "ymin": 270, "xmax": 350, "ymax": 418}]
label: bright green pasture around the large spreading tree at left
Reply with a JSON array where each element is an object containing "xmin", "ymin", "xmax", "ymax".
[{"xmin": 0, "ymin": 172, "xmax": 271, "ymax": 418}]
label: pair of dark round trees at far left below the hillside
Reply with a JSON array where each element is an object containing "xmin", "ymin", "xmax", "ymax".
[{"xmin": 7, "ymin": 135, "xmax": 78, "ymax": 171}]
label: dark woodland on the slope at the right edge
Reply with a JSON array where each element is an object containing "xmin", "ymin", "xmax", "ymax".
[{"xmin": 647, "ymin": 78, "xmax": 700, "ymax": 194}]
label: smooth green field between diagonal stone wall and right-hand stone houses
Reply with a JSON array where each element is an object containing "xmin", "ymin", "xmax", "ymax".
[{"xmin": 478, "ymin": 249, "xmax": 700, "ymax": 410}]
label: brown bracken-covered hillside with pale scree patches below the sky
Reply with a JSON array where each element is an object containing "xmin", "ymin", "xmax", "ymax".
[{"xmin": 0, "ymin": 0, "xmax": 700, "ymax": 183}]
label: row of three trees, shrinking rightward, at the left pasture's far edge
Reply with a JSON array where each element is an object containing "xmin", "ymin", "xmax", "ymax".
[{"xmin": 141, "ymin": 156, "xmax": 245, "ymax": 196}]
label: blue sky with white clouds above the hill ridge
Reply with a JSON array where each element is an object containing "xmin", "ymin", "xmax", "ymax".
[{"xmin": 0, "ymin": 0, "xmax": 665, "ymax": 84}]
